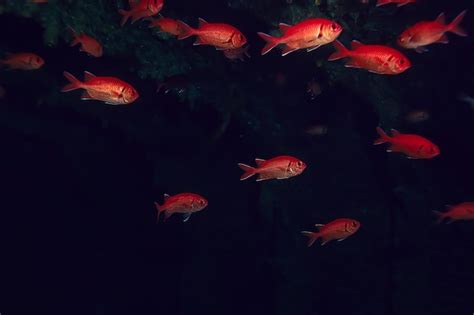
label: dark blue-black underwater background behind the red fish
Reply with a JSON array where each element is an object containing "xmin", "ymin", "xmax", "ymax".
[{"xmin": 0, "ymin": 0, "xmax": 474, "ymax": 315}]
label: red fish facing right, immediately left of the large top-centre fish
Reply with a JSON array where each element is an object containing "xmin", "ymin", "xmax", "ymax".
[{"xmin": 178, "ymin": 18, "xmax": 247, "ymax": 50}]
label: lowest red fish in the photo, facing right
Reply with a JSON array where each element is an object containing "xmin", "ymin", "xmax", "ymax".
[{"xmin": 301, "ymin": 219, "xmax": 360, "ymax": 247}]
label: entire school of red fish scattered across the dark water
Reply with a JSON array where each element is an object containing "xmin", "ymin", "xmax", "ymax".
[{"xmin": 0, "ymin": 0, "xmax": 474, "ymax": 246}]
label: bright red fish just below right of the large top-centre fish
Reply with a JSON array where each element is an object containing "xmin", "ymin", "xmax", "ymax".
[{"xmin": 328, "ymin": 40, "xmax": 411, "ymax": 75}]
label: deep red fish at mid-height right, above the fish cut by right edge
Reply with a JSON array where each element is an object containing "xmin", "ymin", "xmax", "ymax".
[{"xmin": 374, "ymin": 127, "xmax": 440, "ymax": 159}]
